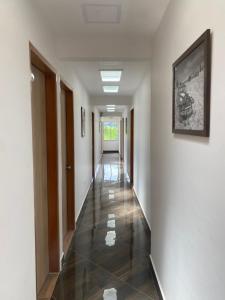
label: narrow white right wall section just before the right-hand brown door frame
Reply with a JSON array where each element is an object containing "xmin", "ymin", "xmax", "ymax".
[{"xmin": 133, "ymin": 73, "xmax": 151, "ymax": 226}]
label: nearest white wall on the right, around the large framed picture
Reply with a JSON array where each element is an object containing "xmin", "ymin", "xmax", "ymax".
[{"xmin": 151, "ymin": 0, "xmax": 225, "ymax": 300}]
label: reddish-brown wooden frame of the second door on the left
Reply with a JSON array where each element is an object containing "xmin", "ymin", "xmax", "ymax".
[{"xmin": 60, "ymin": 80, "xmax": 75, "ymax": 244}]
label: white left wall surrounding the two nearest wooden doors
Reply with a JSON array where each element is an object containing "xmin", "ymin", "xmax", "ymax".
[{"xmin": 0, "ymin": 0, "xmax": 91, "ymax": 300}]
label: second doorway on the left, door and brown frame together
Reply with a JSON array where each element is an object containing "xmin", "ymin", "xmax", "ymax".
[{"xmin": 60, "ymin": 81, "xmax": 75, "ymax": 255}]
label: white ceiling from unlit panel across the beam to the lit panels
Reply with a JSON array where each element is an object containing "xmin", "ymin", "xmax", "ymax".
[{"xmin": 34, "ymin": 0, "xmax": 169, "ymax": 96}]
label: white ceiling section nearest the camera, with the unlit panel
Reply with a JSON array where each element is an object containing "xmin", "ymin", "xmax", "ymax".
[{"xmin": 35, "ymin": 0, "xmax": 169, "ymax": 38}]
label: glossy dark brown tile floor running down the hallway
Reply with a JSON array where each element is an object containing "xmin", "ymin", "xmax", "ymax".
[{"xmin": 52, "ymin": 154, "xmax": 160, "ymax": 300}]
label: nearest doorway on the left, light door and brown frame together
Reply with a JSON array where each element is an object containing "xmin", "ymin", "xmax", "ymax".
[{"xmin": 30, "ymin": 44, "xmax": 59, "ymax": 299}]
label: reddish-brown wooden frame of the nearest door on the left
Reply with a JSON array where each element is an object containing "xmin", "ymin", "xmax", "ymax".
[{"xmin": 29, "ymin": 43, "xmax": 60, "ymax": 284}]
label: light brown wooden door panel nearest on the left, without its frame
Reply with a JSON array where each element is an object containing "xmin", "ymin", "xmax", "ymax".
[{"xmin": 31, "ymin": 66, "xmax": 49, "ymax": 292}]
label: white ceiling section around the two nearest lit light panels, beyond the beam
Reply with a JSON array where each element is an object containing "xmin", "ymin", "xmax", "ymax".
[{"xmin": 73, "ymin": 61, "xmax": 150, "ymax": 95}]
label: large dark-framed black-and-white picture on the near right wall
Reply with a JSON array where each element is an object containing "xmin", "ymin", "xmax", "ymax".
[{"xmin": 173, "ymin": 29, "xmax": 211, "ymax": 137}]
